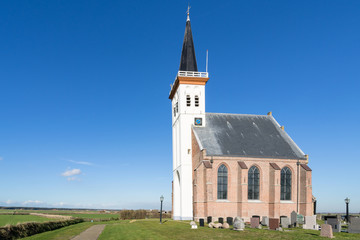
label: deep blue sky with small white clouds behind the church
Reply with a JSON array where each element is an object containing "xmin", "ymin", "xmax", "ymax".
[{"xmin": 0, "ymin": 0, "xmax": 360, "ymax": 212}]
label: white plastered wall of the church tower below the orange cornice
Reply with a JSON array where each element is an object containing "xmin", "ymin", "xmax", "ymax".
[{"xmin": 172, "ymin": 84, "xmax": 205, "ymax": 220}]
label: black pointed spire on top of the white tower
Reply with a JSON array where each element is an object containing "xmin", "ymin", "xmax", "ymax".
[{"xmin": 179, "ymin": 9, "xmax": 197, "ymax": 72}]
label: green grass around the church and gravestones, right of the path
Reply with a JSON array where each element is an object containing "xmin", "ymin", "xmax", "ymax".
[{"xmin": 99, "ymin": 220, "xmax": 360, "ymax": 240}]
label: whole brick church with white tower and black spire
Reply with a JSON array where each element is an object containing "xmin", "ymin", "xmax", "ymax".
[{"xmin": 169, "ymin": 12, "xmax": 313, "ymax": 221}]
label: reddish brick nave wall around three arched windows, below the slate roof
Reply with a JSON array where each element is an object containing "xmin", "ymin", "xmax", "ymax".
[{"xmin": 192, "ymin": 130, "xmax": 313, "ymax": 221}]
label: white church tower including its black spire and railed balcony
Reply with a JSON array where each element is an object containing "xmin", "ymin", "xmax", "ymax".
[{"xmin": 169, "ymin": 10, "xmax": 209, "ymax": 220}]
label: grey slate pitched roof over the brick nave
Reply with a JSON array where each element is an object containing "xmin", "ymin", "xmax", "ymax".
[{"xmin": 193, "ymin": 113, "xmax": 306, "ymax": 159}]
